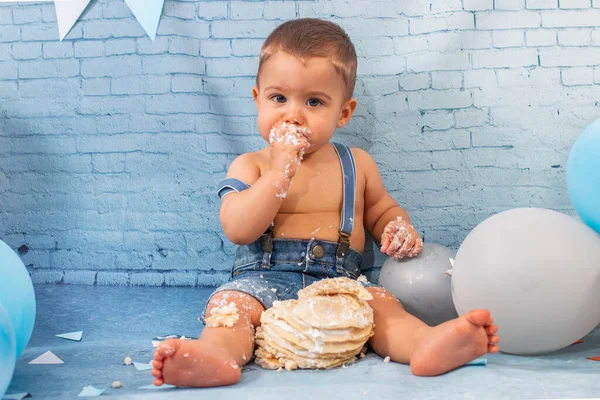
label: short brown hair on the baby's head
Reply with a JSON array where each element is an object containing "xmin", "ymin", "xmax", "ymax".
[{"xmin": 256, "ymin": 18, "xmax": 357, "ymax": 98}]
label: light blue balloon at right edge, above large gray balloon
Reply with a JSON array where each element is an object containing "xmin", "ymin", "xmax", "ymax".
[{"xmin": 567, "ymin": 119, "xmax": 600, "ymax": 233}]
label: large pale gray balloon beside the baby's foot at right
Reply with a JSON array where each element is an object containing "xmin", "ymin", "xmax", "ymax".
[{"xmin": 452, "ymin": 208, "xmax": 600, "ymax": 355}]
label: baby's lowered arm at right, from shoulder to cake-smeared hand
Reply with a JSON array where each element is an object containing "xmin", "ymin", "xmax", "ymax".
[{"xmin": 353, "ymin": 149, "xmax": 423, "ymax": 258}]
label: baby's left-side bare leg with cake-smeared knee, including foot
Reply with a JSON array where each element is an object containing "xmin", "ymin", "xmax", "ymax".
[{"xmin": 152, "ymin": 291, "xmax": 264, "ymax": 387}]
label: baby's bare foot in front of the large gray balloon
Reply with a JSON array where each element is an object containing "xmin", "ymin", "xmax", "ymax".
[{"xmin": 410, "ymin": 310, "xmax": 500, "ymax": 376}]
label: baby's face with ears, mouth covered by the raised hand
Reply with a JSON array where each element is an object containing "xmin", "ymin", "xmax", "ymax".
[{"xmin": 252, "ymin": 51, "xmax": 355, "ymax": 153}]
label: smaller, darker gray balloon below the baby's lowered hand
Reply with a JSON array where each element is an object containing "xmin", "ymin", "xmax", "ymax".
[{"xmin": 378, "ymin": 243, "xmax": 458, "ymax": 326}]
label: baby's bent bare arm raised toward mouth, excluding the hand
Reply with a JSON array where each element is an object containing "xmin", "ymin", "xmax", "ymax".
[{"xmin": 219, "ymin": 153, "xmax": 289, "ymax": 245}]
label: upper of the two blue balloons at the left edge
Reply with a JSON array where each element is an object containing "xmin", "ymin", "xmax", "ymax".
[{"xmin": 0, "ymin": 240, "xmax": 35, "ymax": 358}]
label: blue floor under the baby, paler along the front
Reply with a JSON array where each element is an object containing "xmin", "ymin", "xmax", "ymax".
[{"xmin": 8, "ymin": 285, "xmax": 600, "ymax": 400}]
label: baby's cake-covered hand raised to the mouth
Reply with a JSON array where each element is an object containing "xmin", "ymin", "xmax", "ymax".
[{"xmin": 269, "ymin": 123, "xmax": 311, "ymax": 179}]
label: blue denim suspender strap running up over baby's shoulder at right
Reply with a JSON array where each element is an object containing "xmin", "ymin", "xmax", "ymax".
[{"xmin": 332, "ymin": 143, "xmax": 356, "ymax": 264}]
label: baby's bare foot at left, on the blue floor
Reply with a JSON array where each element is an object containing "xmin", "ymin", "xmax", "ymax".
[{"xmin": 152, "ymin": 339, "xmax": 241, "ymax": 387}]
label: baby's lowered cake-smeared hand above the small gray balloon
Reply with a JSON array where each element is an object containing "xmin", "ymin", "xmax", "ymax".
[{"xmin": 381, "ymin": 217, "xmax": 423, "ymax": 258}]
